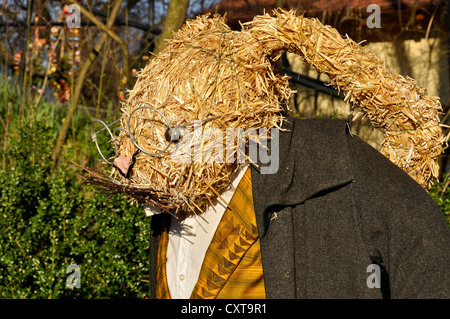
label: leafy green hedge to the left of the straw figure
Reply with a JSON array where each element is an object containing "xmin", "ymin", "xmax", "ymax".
[{"xmin": 0, "ymin": 79, "xmax": 150, "ymax": 298}]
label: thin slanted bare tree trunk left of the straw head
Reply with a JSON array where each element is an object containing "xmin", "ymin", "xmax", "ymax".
[{"xmin": 51, "ymin": 0, "xmax": 125, "ymax": 167}]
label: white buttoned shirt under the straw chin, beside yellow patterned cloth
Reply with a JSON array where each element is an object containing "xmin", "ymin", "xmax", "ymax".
[{"xmin": 144, "ymin": 165, "xmax": 247, "ymax": 299}]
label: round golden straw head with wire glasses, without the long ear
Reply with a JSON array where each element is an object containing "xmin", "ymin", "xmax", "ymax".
[{"xmin": 114, "ymin": 11, "xmax": 291, "ymax": 213}]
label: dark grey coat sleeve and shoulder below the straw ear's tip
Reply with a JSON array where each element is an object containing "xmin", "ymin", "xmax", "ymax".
[{"xmin": 348, "ymin": 136, "xmax": 450, "ymax": 298}]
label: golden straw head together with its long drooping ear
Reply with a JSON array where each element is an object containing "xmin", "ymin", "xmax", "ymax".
[{"xmin": 82, "ymin": 11, "xmax": 446, "ymax": 213}]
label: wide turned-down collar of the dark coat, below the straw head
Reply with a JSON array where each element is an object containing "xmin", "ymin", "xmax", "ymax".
[{"xmin": 252, "ymin": 118, "xmax": 353, "ymax": 237}]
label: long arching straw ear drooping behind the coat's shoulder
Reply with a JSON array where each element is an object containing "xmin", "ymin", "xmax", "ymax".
[{"xmin": 244, "ymin": 10, "xmax": 447, "ymax": 188}]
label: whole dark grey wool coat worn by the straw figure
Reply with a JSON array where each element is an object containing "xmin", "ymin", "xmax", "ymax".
[{"xmin": 150, "ymin": 118, "xmax": 450, "ymax": 298}]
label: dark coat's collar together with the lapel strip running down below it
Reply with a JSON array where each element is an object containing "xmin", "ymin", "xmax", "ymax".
[{"xmin": 252, "ymin": 118, "xmax": 353, "ymax": 298}]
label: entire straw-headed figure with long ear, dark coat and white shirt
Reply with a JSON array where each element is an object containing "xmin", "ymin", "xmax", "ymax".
[{"xmin": 83, "ymin": 11, "xmax": 450, "ymax": 298}]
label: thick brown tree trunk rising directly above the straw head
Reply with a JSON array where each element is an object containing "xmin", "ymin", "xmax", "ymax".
[{"xmin": 153, "ymin": 0, "xmax": 189, "ymax": 54}]
